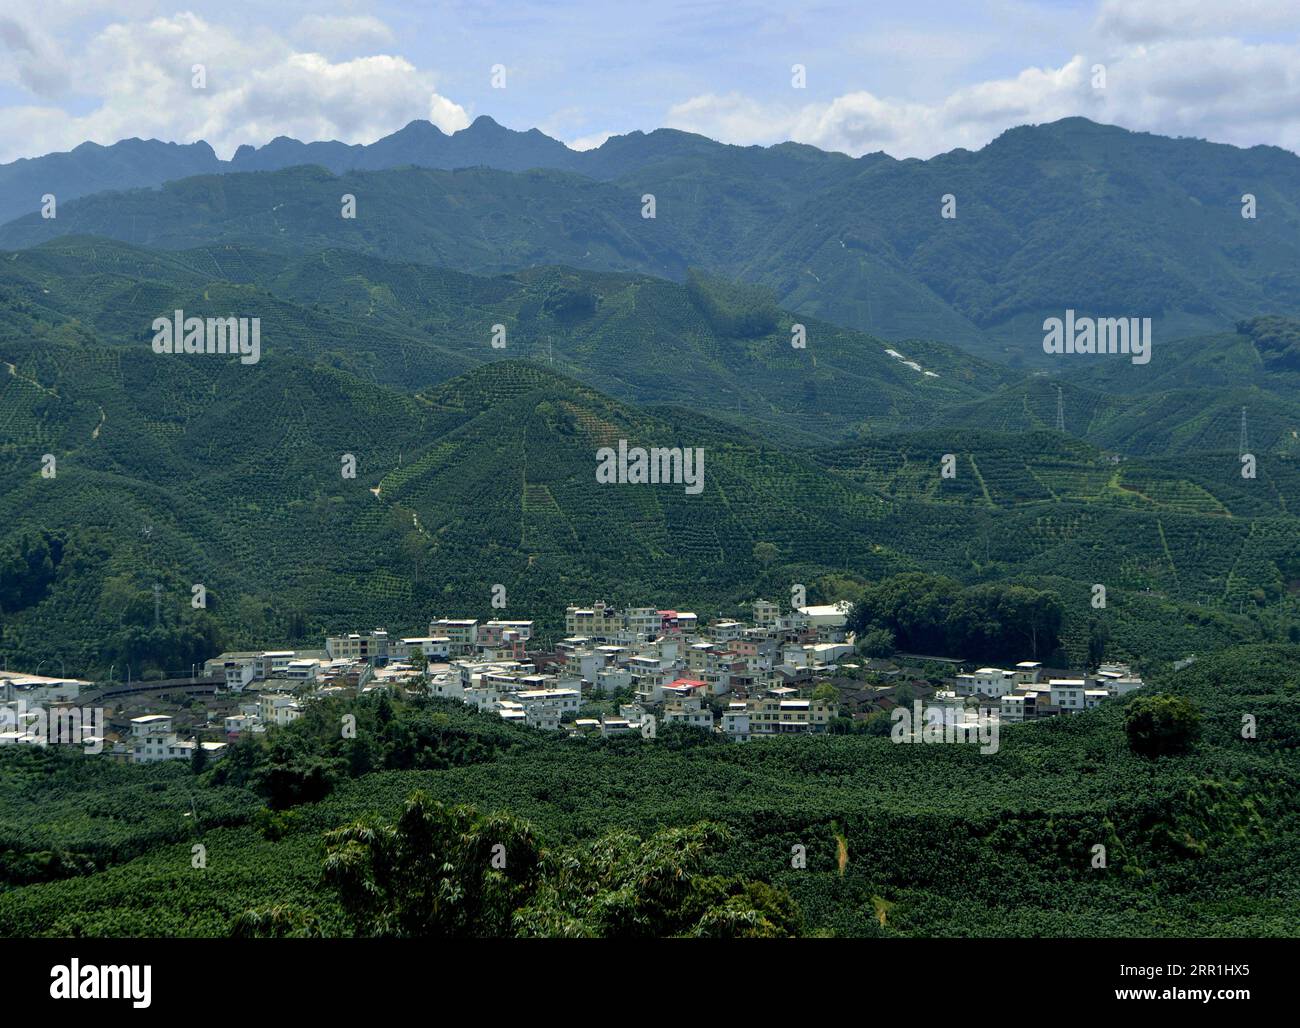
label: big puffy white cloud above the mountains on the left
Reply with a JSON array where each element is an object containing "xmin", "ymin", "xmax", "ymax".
[{"xmin": 0, "ymin": 13, "xmax": 469, "ymax": 161}]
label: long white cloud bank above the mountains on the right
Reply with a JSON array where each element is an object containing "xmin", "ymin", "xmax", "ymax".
[{"xmin": 666, "ymin": 38, "xmax": 1300, "ymax": 157}]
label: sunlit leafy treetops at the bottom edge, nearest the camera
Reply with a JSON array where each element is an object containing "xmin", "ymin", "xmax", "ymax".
[{"xmin": 233, "ymin": 791, "xmax": 801, "ymax": 938}]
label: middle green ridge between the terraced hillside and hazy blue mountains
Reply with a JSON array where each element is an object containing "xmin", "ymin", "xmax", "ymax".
[{"xmin": 0, "ymin": 239, "xmax": 1014, "ymax": 442}]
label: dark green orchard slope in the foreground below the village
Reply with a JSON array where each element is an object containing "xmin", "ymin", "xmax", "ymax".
[{"xmin": 0, "ymin": 646, "xmax": 1300, "ymax": 937}]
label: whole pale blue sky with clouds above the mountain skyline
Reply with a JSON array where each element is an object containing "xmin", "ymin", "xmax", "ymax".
[{"xmin": 0, "ymin": 0, "xmax": 1300, "ymax": 161}]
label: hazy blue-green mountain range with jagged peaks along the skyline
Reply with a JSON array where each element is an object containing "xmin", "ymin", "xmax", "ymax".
[{"xmin": 0, "ymin": 118, "xmax": 1300, "ymax": 366}]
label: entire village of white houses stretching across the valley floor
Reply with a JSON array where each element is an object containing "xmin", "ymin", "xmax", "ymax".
[{"xmin": 0, "ymin": 599, "xmax": 1143, "ymax": 763}]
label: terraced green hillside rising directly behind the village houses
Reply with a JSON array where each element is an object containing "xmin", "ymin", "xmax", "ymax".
[{"xmin": 0, "ymin": 329, "xmax": 1300, "ymax": 675}]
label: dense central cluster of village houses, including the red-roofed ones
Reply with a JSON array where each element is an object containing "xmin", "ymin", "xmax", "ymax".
[{"xmin": 192, "ymin": 600, "xmax": 853, "ymax": 738}]
